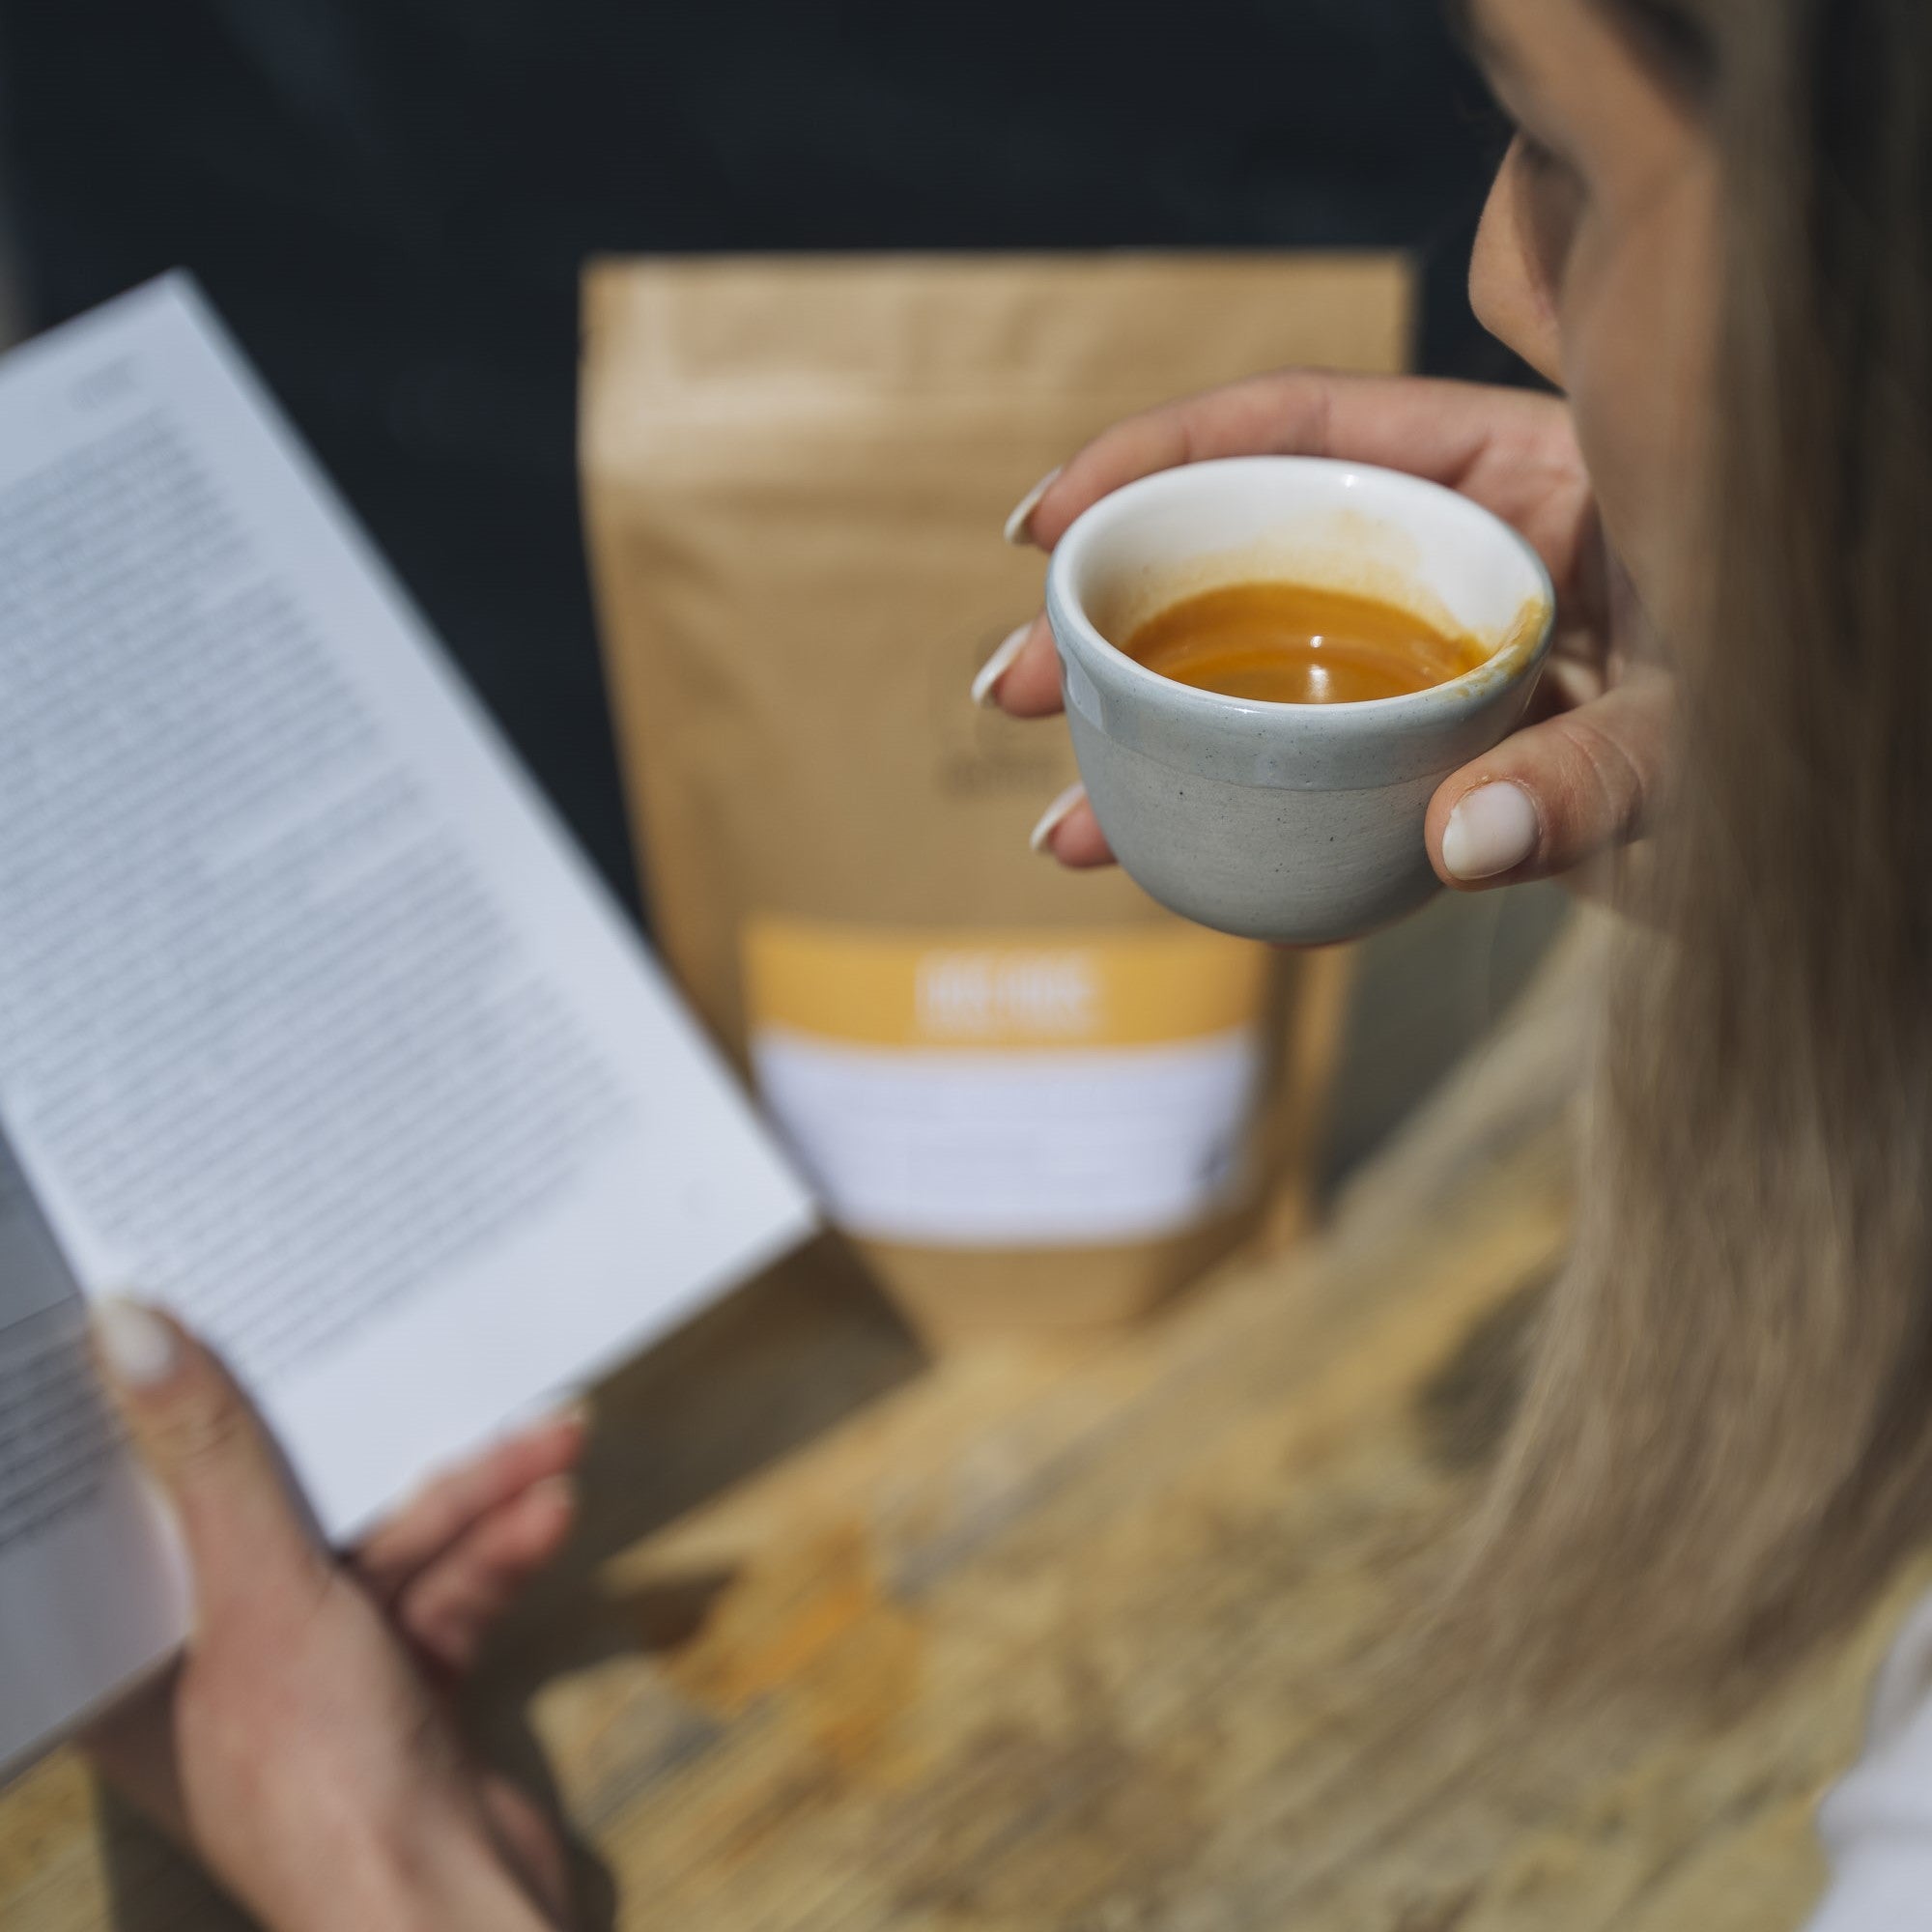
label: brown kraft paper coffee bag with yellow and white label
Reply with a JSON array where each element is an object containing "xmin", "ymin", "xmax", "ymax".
[{"xmin": 583, "ymin": 255, "xmax": 1410, "ymax": 1339}]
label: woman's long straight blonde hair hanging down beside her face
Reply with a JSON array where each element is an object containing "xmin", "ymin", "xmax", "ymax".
[{"xmin": 1472, "ymin": 0, "xmax": 1932, "ymax": 1681}]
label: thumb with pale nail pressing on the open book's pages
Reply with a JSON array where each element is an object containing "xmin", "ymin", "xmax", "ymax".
[{"xmin": 93, "ymin": 1300, "xmax": 328, "ymax": 1627}]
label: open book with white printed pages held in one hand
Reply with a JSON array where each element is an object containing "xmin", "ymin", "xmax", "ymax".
[{"xmin": 0, "ymin": 278, "xmax": 810, "ymax": 1774}]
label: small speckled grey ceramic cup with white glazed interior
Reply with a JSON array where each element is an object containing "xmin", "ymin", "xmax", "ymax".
[{"xmin": 1047, "ymin": 456, "xmax": 1555, "ymax": 945}]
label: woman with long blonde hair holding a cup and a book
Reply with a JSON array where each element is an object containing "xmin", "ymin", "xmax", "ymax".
[{"xmin": 91, "ymin": 0, "xmax": 1932, "ymax": 1932}]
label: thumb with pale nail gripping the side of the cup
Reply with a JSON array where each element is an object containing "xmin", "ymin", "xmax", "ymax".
[{"xmin": 1428, "ymin": 672, "xmax": 1673, "ymax": 891}]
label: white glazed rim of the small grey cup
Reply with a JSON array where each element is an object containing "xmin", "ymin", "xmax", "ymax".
[{"xmin": 1047, "ymin": 456, "xmax": 1557, "ymax": 730}]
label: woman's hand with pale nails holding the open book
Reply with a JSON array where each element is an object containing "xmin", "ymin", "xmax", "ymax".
[{"xmin": 87, "ymin": 1304, "xmax": 583, "ymax": 1932}]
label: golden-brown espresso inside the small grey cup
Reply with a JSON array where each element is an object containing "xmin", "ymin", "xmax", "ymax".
[{"xmin": 1124, "ymin": 582, "xmax": 1492, "ymax": 705}]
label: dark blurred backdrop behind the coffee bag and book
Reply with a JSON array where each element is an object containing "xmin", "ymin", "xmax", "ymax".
[{"xmin": 0, "ymin": 0, "xmax": 1507, "ymax": 898}]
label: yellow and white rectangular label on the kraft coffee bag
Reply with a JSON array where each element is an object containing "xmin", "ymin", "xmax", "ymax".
[{"xmin": 744, "ymin": 920, "xmax": 1271, "ymax": 1246}]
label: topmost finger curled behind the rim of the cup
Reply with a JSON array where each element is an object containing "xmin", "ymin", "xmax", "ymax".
[{"xmin": 1016, "ymin": 369, "xmax": 1575, "ymax": 556}]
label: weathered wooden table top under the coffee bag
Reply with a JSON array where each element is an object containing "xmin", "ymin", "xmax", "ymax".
[{"xmin": 0, "ymin": 931, "xmax": 1924, "ymax": 1932}]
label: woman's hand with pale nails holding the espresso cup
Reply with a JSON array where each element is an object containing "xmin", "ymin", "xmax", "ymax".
[{"xmin": 974, "ymin": 371, "xmax": 1671, "ymax": 891}]
